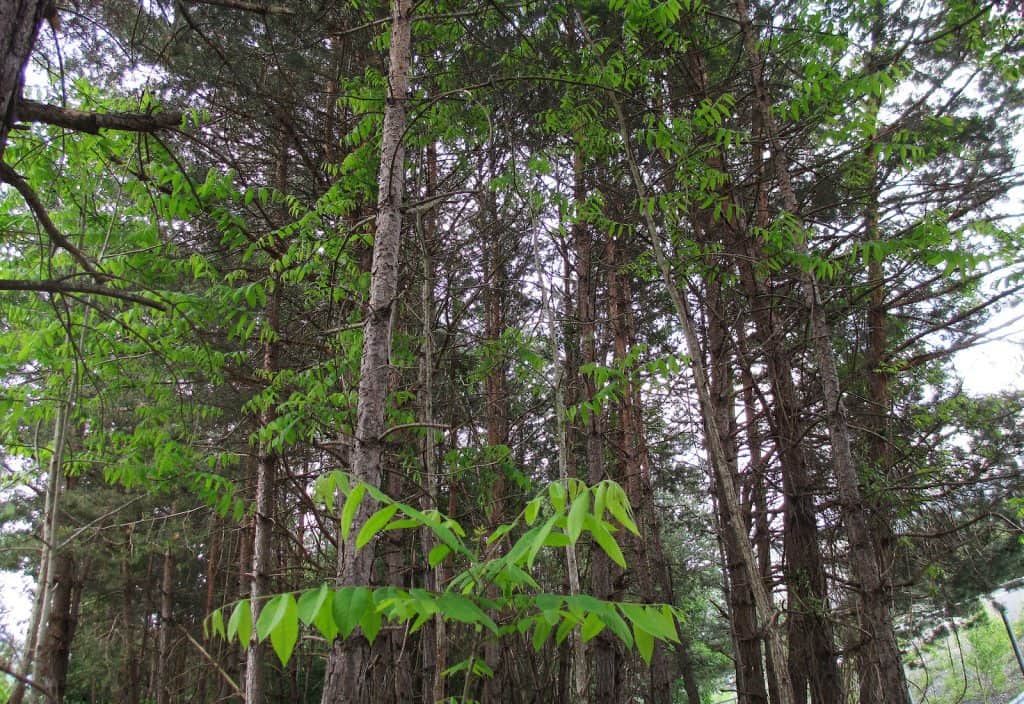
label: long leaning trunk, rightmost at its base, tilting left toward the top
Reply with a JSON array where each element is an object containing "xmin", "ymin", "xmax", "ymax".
[{"xmin": 736, "ymin": 0, "xmax": 910, "ymax": 704}]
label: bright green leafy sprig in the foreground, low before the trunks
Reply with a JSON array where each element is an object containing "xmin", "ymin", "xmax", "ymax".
[{"xmin": 211, "ymin": 472, "xmax": 682, "ymax": 671}]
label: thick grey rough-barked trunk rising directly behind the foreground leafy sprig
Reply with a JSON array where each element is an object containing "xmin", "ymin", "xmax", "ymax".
[{"xmin": 323, "ymin": 0, "xmax": 413, "ymax": 704}]
